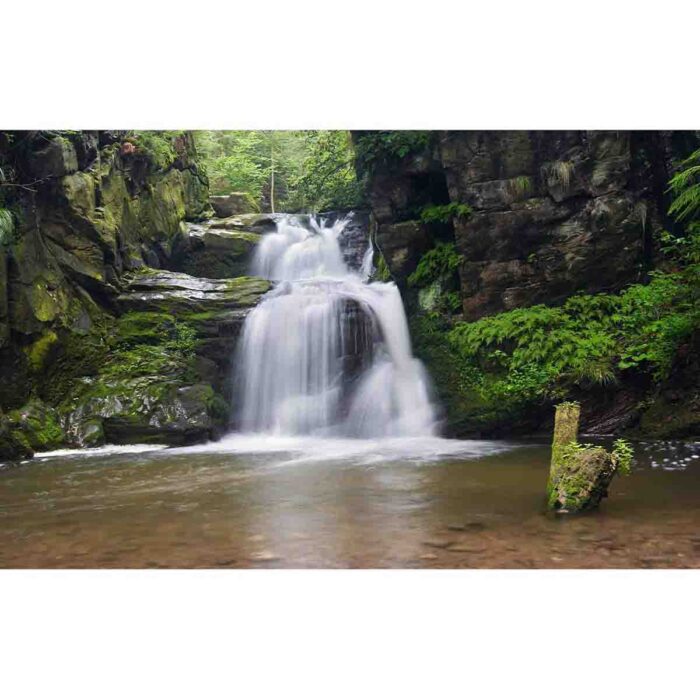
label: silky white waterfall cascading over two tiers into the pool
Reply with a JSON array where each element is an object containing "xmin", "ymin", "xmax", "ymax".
[{"xmin": 234, "ymin": 216, "xmax": 436, "ymax": 438}]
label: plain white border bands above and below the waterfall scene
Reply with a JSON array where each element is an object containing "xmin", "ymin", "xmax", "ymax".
[{"xmin": 0, "ymin": 0, "xmax": 700, "ymax": 700}]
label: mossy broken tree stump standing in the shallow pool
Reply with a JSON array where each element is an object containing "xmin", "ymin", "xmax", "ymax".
[{"xmin": 547, "ymin": 403, "xmax": 629, "ymax": 513}]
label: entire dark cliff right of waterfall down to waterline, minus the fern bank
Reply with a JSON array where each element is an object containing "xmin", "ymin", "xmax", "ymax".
[{"xmin": 353, "ymin": 131, "xmax": 698, "ymax": 434}]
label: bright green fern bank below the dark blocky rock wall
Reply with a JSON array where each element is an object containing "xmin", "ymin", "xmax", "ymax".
[{"xmin": 449, "ymin": 273, "xmax": 700, "ymax": 406}]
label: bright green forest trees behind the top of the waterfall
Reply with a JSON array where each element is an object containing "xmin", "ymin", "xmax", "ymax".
[{"xmin": 196, "ymin": 131, "xmax": 363, "ymax": 211}]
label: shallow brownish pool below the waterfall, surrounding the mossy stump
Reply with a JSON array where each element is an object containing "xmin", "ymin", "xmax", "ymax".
[{"xmin": 0, "ymin": 436, "xmax": 700, "ymax": 568}]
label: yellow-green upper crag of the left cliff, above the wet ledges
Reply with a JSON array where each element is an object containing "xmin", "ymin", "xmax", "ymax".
[{"xmin": 0, "ymin": 131, "xmax": 213, "ymax": 409}]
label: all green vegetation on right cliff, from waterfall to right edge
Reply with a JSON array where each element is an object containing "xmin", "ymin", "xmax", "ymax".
[{"xmin": 409, "ymin": 142, "xmax": 700, "ymax": 432}]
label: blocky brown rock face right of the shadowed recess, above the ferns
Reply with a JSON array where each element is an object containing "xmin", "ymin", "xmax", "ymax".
[{"xmin": 440, "ymin": 132, "xmax": 658, "ymax": 319}]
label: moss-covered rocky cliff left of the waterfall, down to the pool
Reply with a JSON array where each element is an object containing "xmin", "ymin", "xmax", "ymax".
[{"xmin": 0, "ymin": 131, "xmax": 268, "ymax": 456}]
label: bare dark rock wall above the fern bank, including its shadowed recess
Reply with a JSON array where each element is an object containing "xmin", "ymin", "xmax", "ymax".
[{"xmin": 360, "ymin": 131, "xmax": 684, "ymax": 320}]
